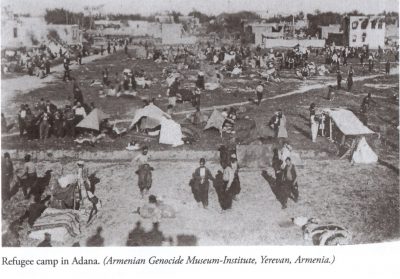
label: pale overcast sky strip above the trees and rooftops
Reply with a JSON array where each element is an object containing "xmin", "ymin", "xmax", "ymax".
[{"xmin": 1, "ymin": 0, "xmax": 399, "ymax": 15}]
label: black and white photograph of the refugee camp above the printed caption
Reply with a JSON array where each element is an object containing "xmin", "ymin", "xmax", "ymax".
[{"xmin": 1, "ymin": 0, "xmax": 400, "ymax": 254}]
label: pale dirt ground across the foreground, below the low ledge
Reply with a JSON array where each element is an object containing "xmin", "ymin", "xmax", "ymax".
[{"xmin": 3, "ymin": 156, "xmax": 399, "ymax": 246}]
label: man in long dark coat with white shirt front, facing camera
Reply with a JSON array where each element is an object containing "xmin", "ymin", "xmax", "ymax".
[{"xmin": 189, "ymin": 158, "xmax": 214, "ymax": 209}]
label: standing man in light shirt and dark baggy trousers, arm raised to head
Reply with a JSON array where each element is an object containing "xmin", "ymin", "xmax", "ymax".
[{"xmin": 131, "ymin": 146, "xmax": 153, "ymax": 198}]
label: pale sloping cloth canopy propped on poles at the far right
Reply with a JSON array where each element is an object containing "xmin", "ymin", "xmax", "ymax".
[{"xmin": 323, "ymin": 108, "xmax": 374, "ymax": 136}]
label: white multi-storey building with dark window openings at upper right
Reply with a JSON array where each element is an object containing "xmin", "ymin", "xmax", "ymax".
[{"xmin": 343, "ymin": 16, "xmax": 386, "ymax": 49}]
